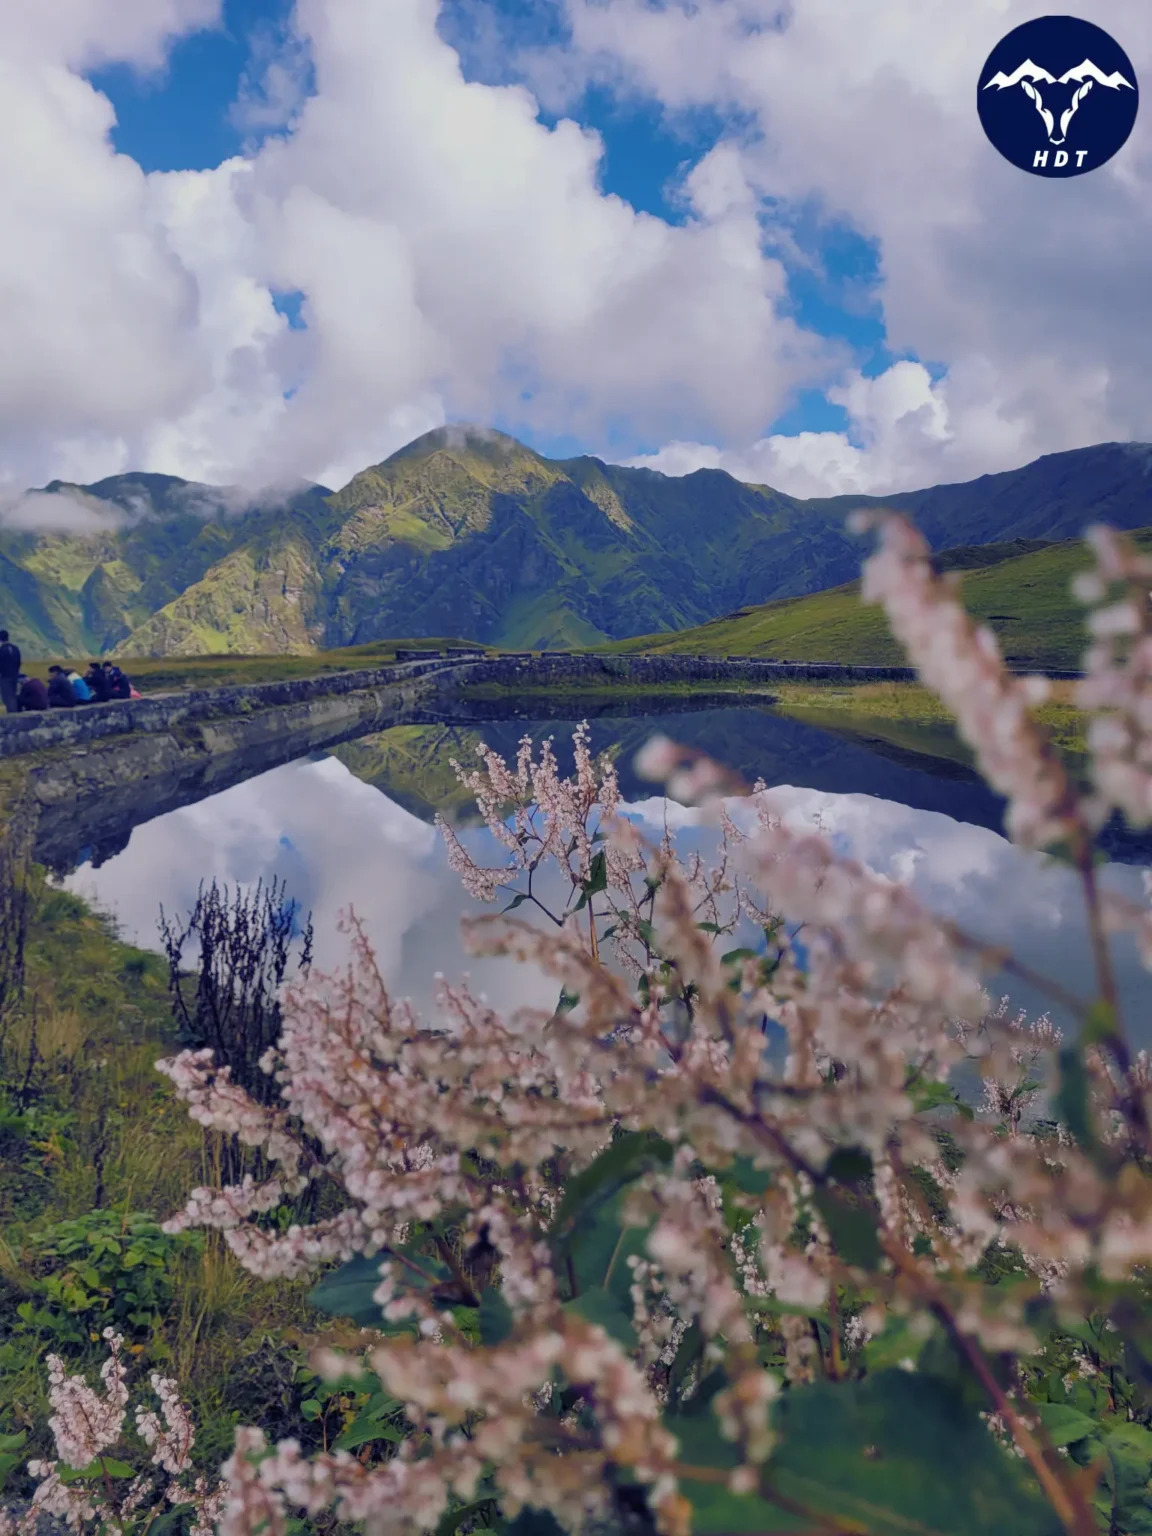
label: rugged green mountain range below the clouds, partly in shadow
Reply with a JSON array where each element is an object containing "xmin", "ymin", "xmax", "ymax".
[{"xmin": 0, "ymin": 427, "xmax": 1152, "ymax": 657}]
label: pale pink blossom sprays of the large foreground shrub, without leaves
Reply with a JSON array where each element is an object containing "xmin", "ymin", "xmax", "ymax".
[{"xmin": 124, "ymin": 518, "xmax": 1152, "ymax": 1536}]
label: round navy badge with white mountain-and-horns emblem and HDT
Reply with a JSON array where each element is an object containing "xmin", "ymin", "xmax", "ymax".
[{"xmin": 975, "ymin": 15, "xmax": 1140, "ymax": 177}]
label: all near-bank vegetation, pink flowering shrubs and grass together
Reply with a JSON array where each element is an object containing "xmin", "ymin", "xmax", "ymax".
[{"xmin": 0, "ymin": 519, "xmax": 1152, "ymax": 1536}]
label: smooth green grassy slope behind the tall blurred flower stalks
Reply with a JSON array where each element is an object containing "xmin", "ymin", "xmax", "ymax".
[{"xmin": 605, "ymin": 528, "xmax": 1152, "ymax": 668}]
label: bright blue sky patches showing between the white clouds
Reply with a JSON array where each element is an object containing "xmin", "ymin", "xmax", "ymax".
[{"xmin": 79, "ymin": 0, "xmax": 921, "ymax": 455}]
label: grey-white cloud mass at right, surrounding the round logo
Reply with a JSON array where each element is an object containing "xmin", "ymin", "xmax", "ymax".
[{"xmin": 545, "ymin": 0, "xmax": 1152, "ymax": 493}]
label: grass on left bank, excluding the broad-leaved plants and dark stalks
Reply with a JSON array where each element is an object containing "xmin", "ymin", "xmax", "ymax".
[{"xmin": 0, "ymin": 869, "xmax": 330, "ymax": 1496}]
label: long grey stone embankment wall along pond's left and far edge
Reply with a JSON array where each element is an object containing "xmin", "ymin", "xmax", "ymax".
[{"xmin": 0, "ymin": 650, "xmax": 1081, "ymax": 866}]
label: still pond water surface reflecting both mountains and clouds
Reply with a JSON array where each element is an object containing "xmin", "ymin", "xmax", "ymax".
[{"xmin": 56, "ymin": 707, "xmax": 1152, "ymax": 1044}]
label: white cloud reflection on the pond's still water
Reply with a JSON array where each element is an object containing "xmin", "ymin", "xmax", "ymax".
[{"xmin": 65, "ymin": 757, "xmax": 1152, "ymax": 1043}]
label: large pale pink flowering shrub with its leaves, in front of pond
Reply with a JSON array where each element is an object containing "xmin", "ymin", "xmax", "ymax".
[{"xmin": 13, "ymin": 516, "xmax": 1152, "ymax": 1536}]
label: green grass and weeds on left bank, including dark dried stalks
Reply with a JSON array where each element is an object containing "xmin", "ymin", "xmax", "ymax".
[{"xmin": 0, "ymin": 866, "xmax": 352, "ymax": 1508}]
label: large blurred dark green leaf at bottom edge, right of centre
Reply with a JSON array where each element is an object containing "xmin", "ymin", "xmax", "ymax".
[{"xmin": 768, "ymin": 1370, "xmax": 1063, "ymax": 1536}]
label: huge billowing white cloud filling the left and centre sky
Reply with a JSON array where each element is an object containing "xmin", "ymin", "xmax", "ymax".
[{"xmin": 0, "ymin": 0, "xmax": 836, "ymax": 494}]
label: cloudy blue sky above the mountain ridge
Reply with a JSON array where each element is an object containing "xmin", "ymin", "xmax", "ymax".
[{"xmin": 0, "ymin": 0, "xmax": 1152, "ymax": 496}]
